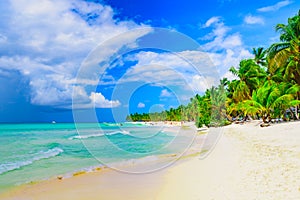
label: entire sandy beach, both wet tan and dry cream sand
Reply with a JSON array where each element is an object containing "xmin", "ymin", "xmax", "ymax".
[{"xmin": 0, "ymin": 121, "xmax": 300, "ymax": 200}]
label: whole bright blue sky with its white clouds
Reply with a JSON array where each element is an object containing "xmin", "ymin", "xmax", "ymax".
[{"xmin": 0, "ymin": 0, "xmax": 300, "ymax": 123}]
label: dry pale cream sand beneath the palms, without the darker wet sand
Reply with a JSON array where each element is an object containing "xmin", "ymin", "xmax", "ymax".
[{"xmin": 158, "ymin": 121, "xmax": 300, "ymax": 199}]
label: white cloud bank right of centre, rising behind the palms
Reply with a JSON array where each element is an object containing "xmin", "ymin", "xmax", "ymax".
[{"xmin": 110, "ymin": 17, "xmax": 252, "ymax": 96}]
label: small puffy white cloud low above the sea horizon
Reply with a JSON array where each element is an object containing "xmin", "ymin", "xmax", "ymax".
[{"xmin": 89, "ymin": 92, "xmax": 121, "ymax": 108}]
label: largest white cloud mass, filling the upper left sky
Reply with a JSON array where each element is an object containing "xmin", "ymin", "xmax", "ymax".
[{"xmin": 0, "ymin": 0, "xmax": 147, "ymax": 107}]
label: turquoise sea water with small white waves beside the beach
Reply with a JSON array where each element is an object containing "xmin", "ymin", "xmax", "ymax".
[{"xmin": 0, "ymin": 123, "xmax": 180, "ymax": 191}]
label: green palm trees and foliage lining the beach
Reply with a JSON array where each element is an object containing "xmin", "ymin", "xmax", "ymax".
[{"xmin": 126, "ymin": 10, "xmax": 300, "ymax": 127}]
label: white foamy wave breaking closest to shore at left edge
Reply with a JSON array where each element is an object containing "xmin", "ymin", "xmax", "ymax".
[{"xmin": 0, "ymin": 147, "xmax": 63, "ymax": 174}]
